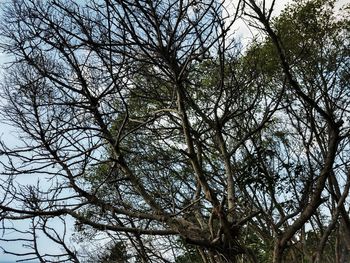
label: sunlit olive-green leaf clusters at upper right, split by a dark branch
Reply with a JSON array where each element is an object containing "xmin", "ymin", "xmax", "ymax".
[{"xmin": 247, "ymin": 0, "xmax": 349, "ymax": 80}]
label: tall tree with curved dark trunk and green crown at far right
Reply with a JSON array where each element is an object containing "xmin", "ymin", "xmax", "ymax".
[{"xmin": 242, "ymin": 1, "xmax": 349, "ymax": 262}]
